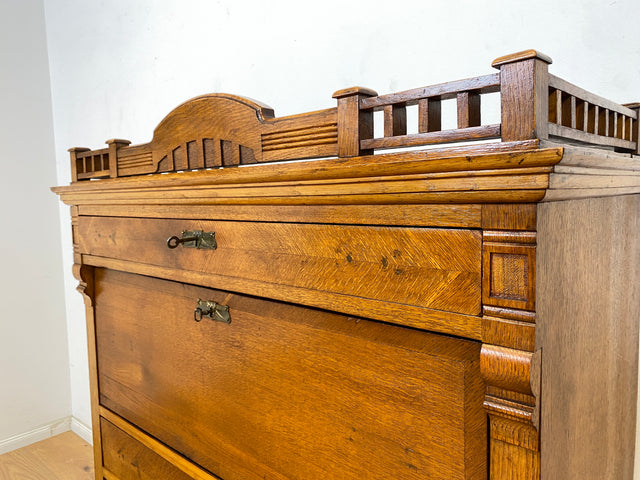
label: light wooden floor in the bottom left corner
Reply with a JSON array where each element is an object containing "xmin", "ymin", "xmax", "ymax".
[{"xmin": 0, "ymin": 432, "xmax": 93, "ymax": 480}]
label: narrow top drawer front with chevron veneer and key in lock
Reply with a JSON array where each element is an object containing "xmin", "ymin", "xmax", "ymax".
[{"xmin": 76, "ymin": 217, "xmax": 481, "ymax": 315}]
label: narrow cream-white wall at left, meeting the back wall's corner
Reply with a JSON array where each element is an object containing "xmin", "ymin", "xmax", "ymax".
[{"xmin": 0, "ymin": 0, "xmax": 71, "ymax": 453}]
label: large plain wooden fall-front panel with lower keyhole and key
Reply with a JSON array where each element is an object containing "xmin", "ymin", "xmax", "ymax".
[{"xmin": 95, "ymin": 269, "xmax": 487, "ymax": 480}]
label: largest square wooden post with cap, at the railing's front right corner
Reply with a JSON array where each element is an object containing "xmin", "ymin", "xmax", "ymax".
[{"xmin": 491, "ymin": 50, "xmax": 552, "ymax": 142}]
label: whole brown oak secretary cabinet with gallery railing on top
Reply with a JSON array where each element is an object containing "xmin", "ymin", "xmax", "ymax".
[{"xmin": 54, "ymin": 50, "xmax": 640, "ymax": 480}]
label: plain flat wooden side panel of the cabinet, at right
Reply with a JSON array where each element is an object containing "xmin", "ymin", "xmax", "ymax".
[{"xmin": 536, "ymin": 195, "xmax": 640, "ymax": 480}]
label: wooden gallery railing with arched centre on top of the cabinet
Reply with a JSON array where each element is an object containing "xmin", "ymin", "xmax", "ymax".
[{"xmin": 70, "ymin": 50, "xmax": 640, "ymax": 181}]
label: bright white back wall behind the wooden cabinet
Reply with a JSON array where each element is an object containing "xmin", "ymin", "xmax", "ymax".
[{"xmin": 45, "ymin": 0, "xmax": 640, "ymax": 468}]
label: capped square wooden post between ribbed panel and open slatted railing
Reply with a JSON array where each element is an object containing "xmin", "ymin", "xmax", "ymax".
[{"xmin": 333, "ymin": 87, "xmax": 378, "ymax": 157}]
